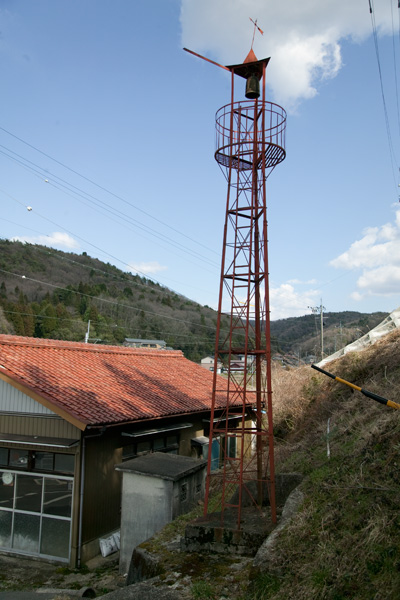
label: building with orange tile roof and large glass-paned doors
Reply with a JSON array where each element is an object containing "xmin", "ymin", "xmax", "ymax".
[{"xmin": 0, "ymin": 335, "xmax": 234, "ymax": 566}]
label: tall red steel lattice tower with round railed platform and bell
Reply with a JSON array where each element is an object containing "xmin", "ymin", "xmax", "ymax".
[{"xmin": 189, "ymin": 49, "xmax": 286, "ymax": 529}]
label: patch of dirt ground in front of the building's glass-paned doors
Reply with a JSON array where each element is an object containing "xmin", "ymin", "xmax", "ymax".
[{"xmin": 0, "ymin": 553, "xmax": 126, "ymax": 596}]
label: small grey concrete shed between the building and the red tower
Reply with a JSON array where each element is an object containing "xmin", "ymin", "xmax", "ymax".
[{"xmin": 115, "ymin": 452, "xmax": 207, "ymax": 573}]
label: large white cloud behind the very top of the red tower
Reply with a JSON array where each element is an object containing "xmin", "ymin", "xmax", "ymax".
[{"xmin": 181, "ymin": 0, "xmax": 391, "ymax": 110}]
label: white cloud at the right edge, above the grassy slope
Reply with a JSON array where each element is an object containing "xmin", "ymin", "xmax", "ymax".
[{"xmin": 330, "ymin": 210, "xmax": 400, "ymax": 300}]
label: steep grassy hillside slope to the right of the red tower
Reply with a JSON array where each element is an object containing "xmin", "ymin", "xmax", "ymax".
[{"xmin": 255, "ymin": 330, "xmax": 400, "ymax": 600}]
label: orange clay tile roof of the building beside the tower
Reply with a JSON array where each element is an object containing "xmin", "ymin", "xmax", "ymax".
[{"xmin": 0, "ymin": 335, "xmax": 226, "ymax": 428}]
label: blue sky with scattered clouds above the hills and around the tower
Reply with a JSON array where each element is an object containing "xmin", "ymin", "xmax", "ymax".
[{"xmin": 0, "ymin": 0, "xmax": 400, "ymax": 319}]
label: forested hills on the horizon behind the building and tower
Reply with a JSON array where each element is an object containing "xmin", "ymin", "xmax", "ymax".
[{"xmin": 0, "ymin": 240, "xmax": 395, "ymax": 361}]
